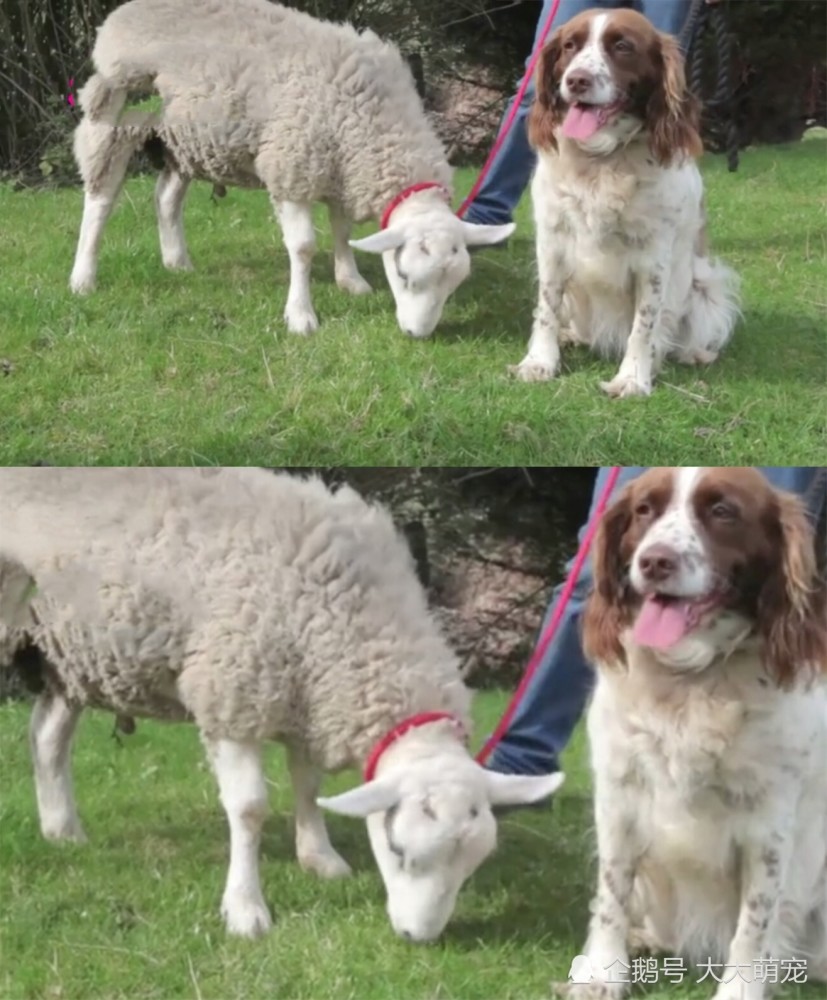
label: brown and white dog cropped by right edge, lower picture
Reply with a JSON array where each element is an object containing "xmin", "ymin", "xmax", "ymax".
[{"xmin": 559, "ymin": 468, "xmax": 827, "ymax": 1000}]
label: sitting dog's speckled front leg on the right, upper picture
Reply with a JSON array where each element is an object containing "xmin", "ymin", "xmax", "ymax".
[{"xmin": 600, "ymin": 250, "xmax": 669, "ymax": 396}]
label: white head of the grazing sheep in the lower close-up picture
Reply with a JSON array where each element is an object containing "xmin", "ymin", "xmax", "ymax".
[{"xmin": 318, "ymin": 741, "xmax": 564, "ymax": 942}]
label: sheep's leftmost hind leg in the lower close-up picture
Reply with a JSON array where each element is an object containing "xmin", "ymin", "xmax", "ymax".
[{"xmin": 29, "ymin": 691, "xmax": 86, "ymax": 843}]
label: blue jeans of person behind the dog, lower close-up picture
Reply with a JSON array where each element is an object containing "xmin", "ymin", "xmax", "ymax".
[{"xmin": 487, "ymin": 466, "xmax": 827, "ymax": 774}]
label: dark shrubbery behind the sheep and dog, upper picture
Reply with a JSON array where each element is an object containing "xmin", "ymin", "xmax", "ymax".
[{"xmin": 0, "ymin": 0, "xmax": 827, "ymax": 182}]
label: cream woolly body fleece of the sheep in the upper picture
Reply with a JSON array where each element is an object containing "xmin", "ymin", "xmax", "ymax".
[{"xmin": 81, "ymin": 0, "xmax": 452, "ymax": 222}]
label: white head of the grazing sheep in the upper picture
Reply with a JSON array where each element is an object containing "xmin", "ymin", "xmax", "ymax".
[{"xmin": 350, "ymin": 199, "xmax": 514, "ymax": 338}]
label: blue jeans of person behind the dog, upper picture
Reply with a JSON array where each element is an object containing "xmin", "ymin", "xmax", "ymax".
[{"xmin": 464, "ymin": 0, "xmax": 691, "ymax": 225}]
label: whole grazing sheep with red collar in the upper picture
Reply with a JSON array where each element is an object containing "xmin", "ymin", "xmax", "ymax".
[{"xmin": 70, "ymin": 0, "xmax": 514, "ymax": 337}]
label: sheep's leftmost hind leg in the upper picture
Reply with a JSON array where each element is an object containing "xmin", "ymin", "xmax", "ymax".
[{"xmin": 69, "ymin": 119, "xmax": 140, "ymax": 293}]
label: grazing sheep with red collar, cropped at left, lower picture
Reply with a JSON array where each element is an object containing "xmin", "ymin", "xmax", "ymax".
[{"xmin": 0, "ymin": 468, "xmax": 563, "ymax": 940}]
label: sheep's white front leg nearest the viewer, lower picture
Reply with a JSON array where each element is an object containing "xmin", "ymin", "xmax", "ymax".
[{"xmin": 206, "ymin": 740, "xmax": 273, "ymax": 937}]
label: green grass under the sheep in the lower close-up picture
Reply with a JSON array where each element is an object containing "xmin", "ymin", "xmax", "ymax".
[{"xmin": 0, "ymin": 693, "xmax": 824, "ymax": 1000}]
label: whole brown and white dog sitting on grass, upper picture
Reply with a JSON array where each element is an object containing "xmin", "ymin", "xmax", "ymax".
[{"xmin": 511, "ymin": 10, "xmax": 739, "ymax": 396}]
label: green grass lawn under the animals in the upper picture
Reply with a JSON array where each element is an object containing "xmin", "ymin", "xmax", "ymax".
[{"xmin": 0, "ymin": 137, "xmax": 827, "ymax": 465}]
